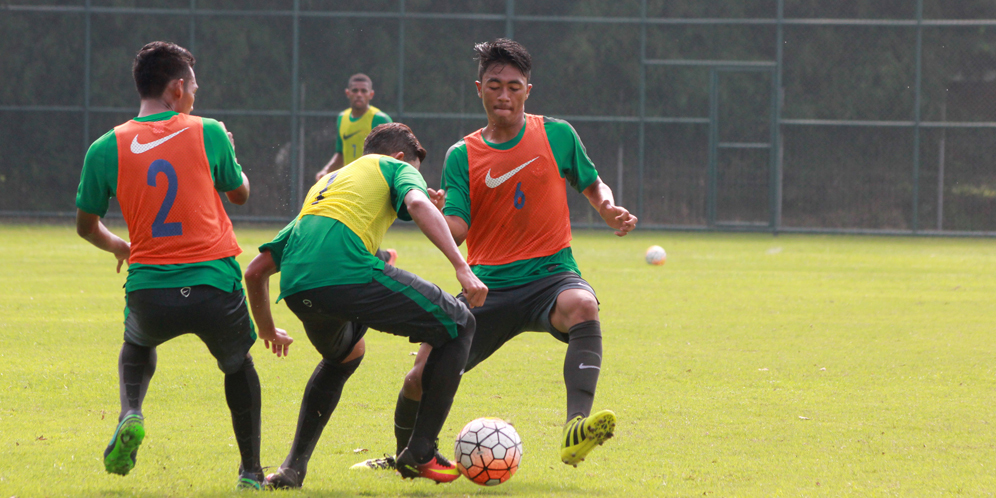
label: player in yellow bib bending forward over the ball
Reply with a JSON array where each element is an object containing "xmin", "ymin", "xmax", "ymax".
[{"xmin": 246, "ymin": 123, "xmax": 488, "ymax": 488}]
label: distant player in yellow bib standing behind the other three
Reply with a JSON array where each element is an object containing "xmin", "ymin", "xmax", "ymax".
[{"xmin": 315, "ymin": 73, "xmax": 391, "ymax": 181}]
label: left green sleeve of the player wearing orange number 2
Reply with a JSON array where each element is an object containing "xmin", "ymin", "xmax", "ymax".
[{"xmin": 76, "ymin": 130, "xmax": 118, "ymax": 217}]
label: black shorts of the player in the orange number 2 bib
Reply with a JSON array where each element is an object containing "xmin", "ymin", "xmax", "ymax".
[{"xmin": 124, "ymin": 285, "xmax": 256, "ymax": 374}]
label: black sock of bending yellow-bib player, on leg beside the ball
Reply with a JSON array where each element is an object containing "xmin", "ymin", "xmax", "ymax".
[{"xmin": 408, "ymin": 315, "xmax": 476, "ymax": 463}]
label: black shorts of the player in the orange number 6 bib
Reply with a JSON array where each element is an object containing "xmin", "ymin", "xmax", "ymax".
[{"xmin": 459, "ymin": 272, "xmax": 597, "ymax": 371}]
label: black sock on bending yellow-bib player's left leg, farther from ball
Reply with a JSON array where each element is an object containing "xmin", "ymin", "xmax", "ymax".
[{"xmin": 283, "ymin": 356, "xmax": 363, "ymax": 476}]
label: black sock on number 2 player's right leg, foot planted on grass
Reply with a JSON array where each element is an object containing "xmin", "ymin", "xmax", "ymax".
[{"xmin": 225, "ymin": 354, "xmax": 263, "ymax": 472}]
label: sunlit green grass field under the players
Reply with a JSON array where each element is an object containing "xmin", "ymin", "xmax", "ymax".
[{"xmin": 0, "ymin": 224, "xmax": 996, "ymax": 498}]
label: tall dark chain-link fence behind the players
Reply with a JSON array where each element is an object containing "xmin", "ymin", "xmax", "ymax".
[{"xmin": 0, "ymin": 0, "xmax": 996, "ymax": 233}]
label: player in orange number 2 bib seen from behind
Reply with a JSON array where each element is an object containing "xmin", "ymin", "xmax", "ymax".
[{"xmin": 76, "ymin": 42, "xmax": 290, "ymax": 489}]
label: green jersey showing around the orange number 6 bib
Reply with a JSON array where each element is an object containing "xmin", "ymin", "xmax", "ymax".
[{"xmin": 441, "ymin": 117, "xmax": 598, "ymax": 289}]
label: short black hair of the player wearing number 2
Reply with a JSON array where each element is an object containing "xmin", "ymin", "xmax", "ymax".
[{"xmin": 131, "ymin": 41, "xmax": 196, "ymax": 99}]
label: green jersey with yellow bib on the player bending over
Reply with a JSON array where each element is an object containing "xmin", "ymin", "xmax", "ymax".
[{"xmin": 268, "ymin": 154, "xmax": 428, "ymax": 302}]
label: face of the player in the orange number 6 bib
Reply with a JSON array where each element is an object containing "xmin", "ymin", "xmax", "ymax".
[{"xmin": 475, "ymin": 64, "xmax": 533, "ymax": 126}]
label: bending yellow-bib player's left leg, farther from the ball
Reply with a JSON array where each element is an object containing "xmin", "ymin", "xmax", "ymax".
[{"xmin": 266, "ymin": 294, "xmax": 366, "ymax": 488}]
